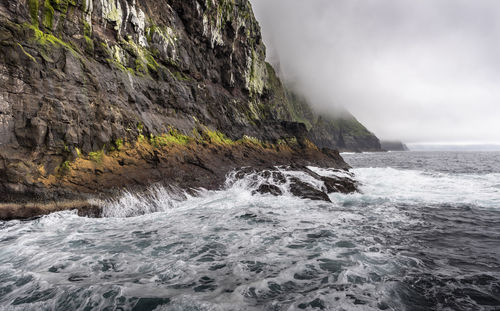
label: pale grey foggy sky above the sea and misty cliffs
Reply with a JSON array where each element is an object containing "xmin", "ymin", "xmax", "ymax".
[{"xmin": 251, "ymin": 0, "xmax": 500, "ymax": 143}]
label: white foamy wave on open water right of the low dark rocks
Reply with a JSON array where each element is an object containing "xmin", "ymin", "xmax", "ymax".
[{"xmin": 335, "ymin": 168, "xmax": 500, "ymax": 208}]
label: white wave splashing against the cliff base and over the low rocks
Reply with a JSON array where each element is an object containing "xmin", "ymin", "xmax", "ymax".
[{"xmin": 99, "ymin": 167, "xmax": 354, "ymax": 218}]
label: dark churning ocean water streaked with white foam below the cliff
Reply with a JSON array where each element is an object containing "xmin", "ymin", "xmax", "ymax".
[{"xmin": 0, "ymin": 152, "xmax": 500, "ymax": 310}]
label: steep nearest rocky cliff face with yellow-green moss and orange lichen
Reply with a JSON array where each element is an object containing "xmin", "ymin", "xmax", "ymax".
[{"xmin": 0, "ymin": 0, "xmax": 347, "ymax": 206}]
